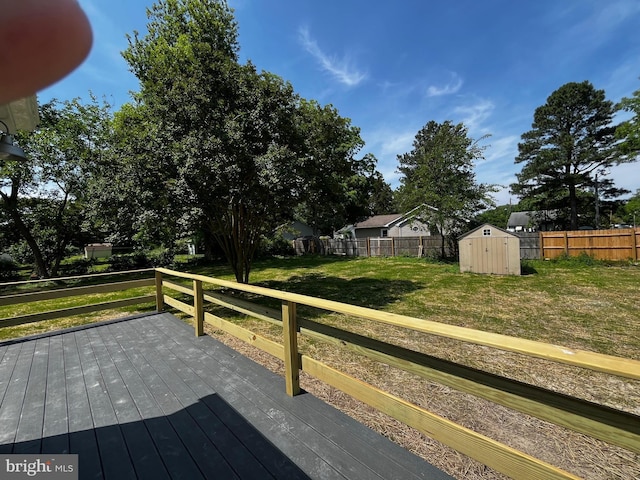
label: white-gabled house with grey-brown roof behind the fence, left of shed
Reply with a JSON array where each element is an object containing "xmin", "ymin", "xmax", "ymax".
[{"xmin": 338, "ymin": 205, "xmax": 436, "ymax": 238}]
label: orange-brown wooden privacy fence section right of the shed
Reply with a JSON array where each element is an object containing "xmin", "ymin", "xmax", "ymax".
[{"xmin": 540, "ymin": 228, "xmax": 640, "ymax": 261}]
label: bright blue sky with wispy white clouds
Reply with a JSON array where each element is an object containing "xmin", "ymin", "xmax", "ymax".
[{"xmin": 39, "ymin": 0, "xmax": 640, "ymax": 204}]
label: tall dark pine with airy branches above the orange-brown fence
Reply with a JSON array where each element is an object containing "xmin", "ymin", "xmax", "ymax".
[{"xmin": 511, "ymin": 81, "xmax": 633, "ymax": 229}]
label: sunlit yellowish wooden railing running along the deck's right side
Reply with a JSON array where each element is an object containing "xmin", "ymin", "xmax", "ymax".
[{"xmin": 156, "ymin": 268, "xmax": 640, "ymax": 479}]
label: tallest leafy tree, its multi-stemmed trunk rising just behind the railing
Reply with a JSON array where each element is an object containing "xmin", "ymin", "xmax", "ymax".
[{"xmin": 124, "ymin": 0, "xmax": 301, "ymax": 282}]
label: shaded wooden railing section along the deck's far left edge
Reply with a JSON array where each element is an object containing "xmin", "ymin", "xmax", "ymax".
[{"xmin": 0, "ymin": 268, "xmax": 157, "ymax": 327}]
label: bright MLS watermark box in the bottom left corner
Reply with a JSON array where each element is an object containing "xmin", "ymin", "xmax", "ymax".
[{"xmin": 0, "ymin": 454, "xmax": 78, "ymax": 480}]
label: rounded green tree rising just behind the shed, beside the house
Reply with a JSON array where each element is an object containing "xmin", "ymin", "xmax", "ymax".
[{"xmin": 396, "ymin": 120, "xmax": 494, "ymax": 256}]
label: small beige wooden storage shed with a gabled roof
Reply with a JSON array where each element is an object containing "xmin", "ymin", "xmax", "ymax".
[{"xmin": 458, "ymin": 223, "xmax": 520, "ymax": 275}]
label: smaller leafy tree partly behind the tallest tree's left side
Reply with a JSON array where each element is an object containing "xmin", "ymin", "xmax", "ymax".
[{"xmin": 88, "ymin": 103, "xmax": 184, "ymax": 250}]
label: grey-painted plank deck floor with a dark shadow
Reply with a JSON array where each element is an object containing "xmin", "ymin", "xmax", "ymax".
[{"xmin": 0, "ymin": 313, "xmax": 450, "ymax": 480}]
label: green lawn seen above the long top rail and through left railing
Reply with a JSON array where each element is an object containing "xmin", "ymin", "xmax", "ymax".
[{"xmin": 0, "ymin": 256, "xmax": 640, "ymax": 358}]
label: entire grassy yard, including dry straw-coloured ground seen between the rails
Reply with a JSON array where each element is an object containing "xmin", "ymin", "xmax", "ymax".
[{"xmin": 0, "ymin": 256, "xmax": 640, "ymax": 479}]
